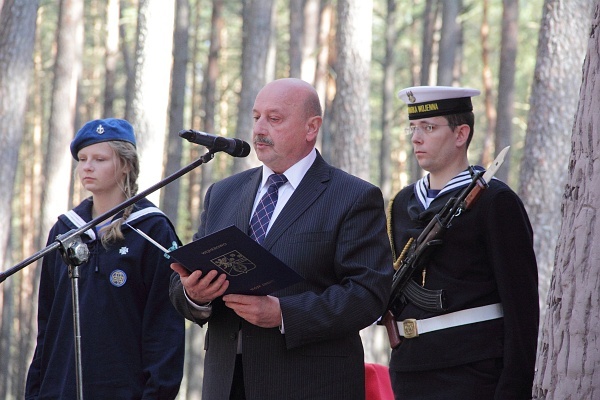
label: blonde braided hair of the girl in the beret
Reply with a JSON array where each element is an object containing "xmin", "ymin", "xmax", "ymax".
[{"xmin": 100, "ymin": 140, "xmax": 140, "ymax": 248}]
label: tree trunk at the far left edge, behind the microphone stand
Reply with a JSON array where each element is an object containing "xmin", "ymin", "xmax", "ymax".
[{"xmin": 0, "ymin": 0, "xmax": 38, "ymax": 398}]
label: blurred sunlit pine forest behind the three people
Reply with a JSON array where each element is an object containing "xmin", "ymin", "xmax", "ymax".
[{"xmin": 0, "ymin": 0, "xmax": 600, "ymax": 399}]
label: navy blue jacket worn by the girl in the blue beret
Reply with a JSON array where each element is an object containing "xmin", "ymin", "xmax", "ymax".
[{"xmin": 25, "ymin": 199, "xmax": 184, "ymax": 400}]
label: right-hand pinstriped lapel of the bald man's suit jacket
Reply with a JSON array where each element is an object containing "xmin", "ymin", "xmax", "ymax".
[{"xmin": 263, "ymin": 153, "xmax": 331, "ymax": 249}]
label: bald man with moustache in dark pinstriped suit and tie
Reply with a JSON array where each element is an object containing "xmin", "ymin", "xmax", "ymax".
[{"xmin": 170, "ymin": 78, "xmax": 392, "ymax": 400}]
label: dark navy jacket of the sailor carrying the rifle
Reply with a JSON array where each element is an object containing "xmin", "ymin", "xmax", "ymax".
[{"xmin": 390, "ymin": 170, "xmax": 539, "ymax": 399}]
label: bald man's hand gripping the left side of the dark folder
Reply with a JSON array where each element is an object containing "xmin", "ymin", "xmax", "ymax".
[{"xmin": 171, "ymin": 263, "xmax": 229, "ymax": 305}]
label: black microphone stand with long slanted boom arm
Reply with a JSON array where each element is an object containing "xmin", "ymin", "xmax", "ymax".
[{"xmin": 0, "ymin": 148, "xmax": 219, "ymax": 400}]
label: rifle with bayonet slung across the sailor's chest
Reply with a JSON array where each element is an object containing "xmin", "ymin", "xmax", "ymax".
[{"xmin": 382, "ymin": 146, "xmax": 510, "ymax": 349}]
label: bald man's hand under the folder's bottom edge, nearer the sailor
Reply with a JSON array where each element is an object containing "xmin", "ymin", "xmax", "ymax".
[{"xmin": 223, "ymin": 294, "xmax": 281, "ymax": 328}]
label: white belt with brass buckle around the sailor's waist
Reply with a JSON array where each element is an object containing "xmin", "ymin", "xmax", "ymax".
[{"xmin": 397, "ymin": 303, "xmax": 503, "ymax": 339}]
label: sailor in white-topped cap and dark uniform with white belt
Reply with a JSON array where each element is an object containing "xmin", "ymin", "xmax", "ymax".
[{"xmin": 389, "ymin": 86, "xmax": 539, "ymax": 400}]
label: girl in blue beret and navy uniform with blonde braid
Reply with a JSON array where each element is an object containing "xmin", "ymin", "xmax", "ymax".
[{"xmin": 25, "ymin": 118, "xmax": 184, "ymax": 400}]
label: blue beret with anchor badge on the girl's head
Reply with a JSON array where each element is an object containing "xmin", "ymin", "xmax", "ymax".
[{"xmin": 71, "ymin": 118, "xmax": 135, "ymax": 161}]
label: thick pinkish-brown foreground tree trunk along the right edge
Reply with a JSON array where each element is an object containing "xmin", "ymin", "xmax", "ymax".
[{"xmin": 533, "ymin": 0, "xmax": 600, "ymax": 400}]
